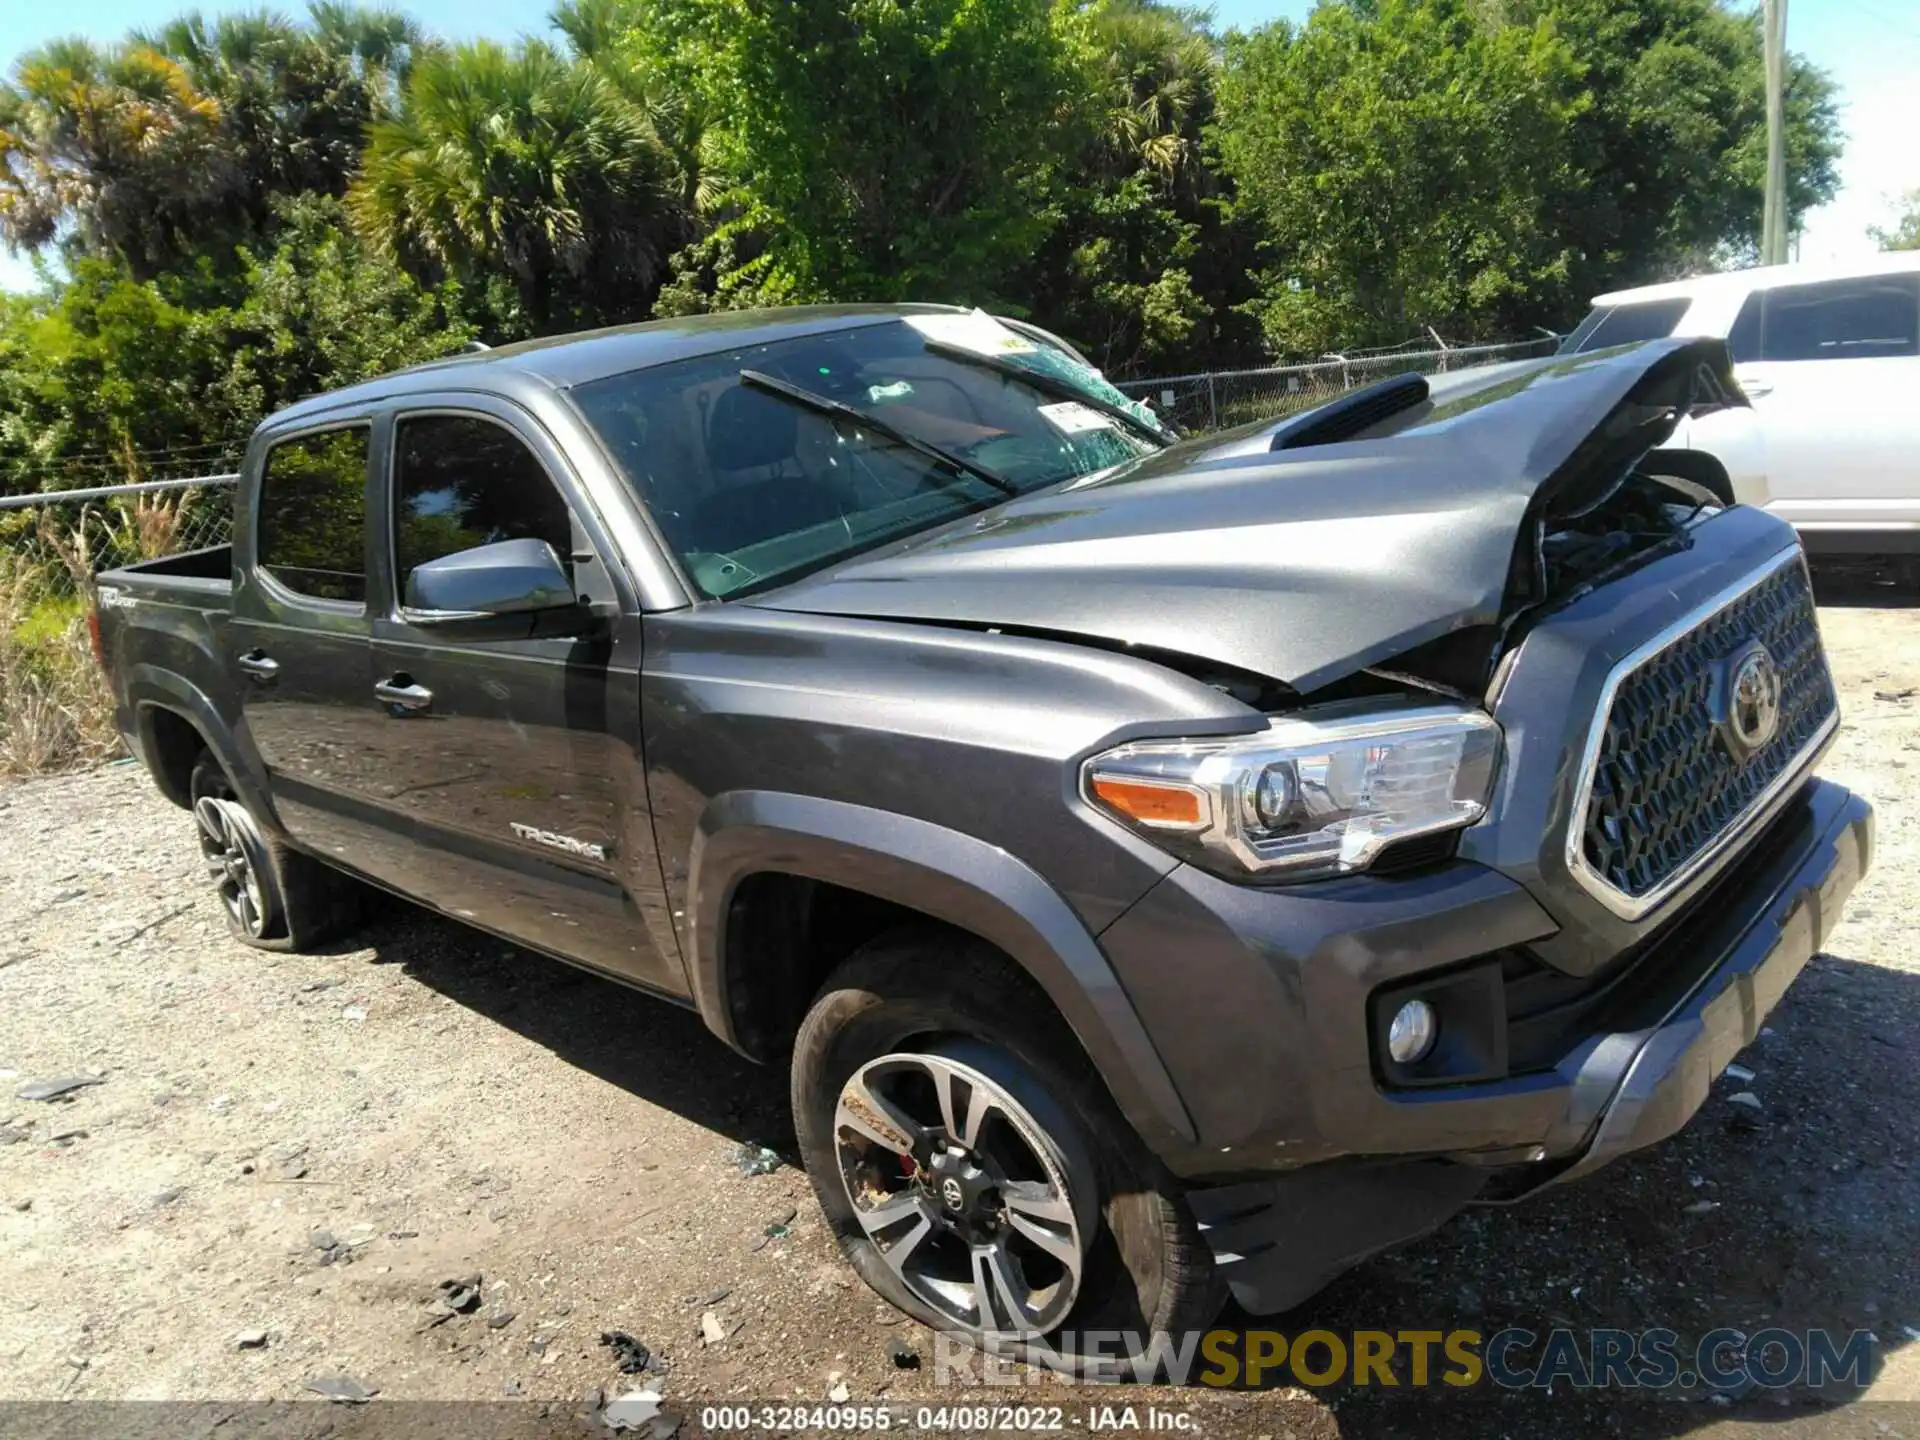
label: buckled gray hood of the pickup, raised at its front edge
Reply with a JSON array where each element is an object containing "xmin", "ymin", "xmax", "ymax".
[{"xmin": 751, "ymin": 340, "xmax": 1738, "ymax": 708}]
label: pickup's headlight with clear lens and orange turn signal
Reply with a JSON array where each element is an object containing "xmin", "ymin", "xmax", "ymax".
[{"xmin": 1083, "ymin": 703, "xmax": 1500, "ymax": 879}]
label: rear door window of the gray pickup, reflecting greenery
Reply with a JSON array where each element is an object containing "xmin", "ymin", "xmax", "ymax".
[{"xmin": 255, "ymin": 424, "xmax": 372, "ymax": 605}]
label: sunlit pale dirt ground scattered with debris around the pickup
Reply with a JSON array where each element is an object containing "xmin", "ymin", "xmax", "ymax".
[{"xmin": 0, "ymin": 576, "xmax": 1920, "ymax": 1436}]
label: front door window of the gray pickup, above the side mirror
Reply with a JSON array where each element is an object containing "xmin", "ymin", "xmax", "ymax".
[{"xmin": 394, "ymin": 415, "xmax": 574, "ymax": 595}]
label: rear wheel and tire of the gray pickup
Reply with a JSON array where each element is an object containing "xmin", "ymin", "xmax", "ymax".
[{"xmin": 188, "ymin": 751, "xmax": 363, "ymax": 950}]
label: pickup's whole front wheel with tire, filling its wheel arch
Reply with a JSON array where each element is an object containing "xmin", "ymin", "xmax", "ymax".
[{"xmin": 793, "ymin": 929, "xmax": 1225, "ymax": 1375}]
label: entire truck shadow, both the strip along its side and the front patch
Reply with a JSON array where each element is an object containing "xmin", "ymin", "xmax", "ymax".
[{"xmin": 341, "ymin": 906, "xmax": 1920, "ymax": 1436}]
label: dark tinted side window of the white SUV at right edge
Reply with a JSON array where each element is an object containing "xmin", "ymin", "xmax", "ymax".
[{"xmin": 1728, "ymin": 275, "xmax": 1920, "ymax": 361}]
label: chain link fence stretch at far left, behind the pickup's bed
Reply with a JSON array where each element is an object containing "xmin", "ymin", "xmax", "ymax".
[{"xmin": 0, "ymin": 474, "xmax": 238, "ymax": 601}]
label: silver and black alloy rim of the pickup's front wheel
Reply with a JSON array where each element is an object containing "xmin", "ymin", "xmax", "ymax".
[{"xmin": 833, "ymin": 1052, "xmax": 1096, "ymax": 1340}]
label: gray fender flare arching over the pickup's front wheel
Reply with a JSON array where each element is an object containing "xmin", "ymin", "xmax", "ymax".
[{"xmin": 687, "ymin": 791, "xmax": 1196, "ymax": 1148}]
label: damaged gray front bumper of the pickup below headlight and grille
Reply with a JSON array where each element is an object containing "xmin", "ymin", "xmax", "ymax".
[{"xmin": 1104, "ymin": 780, "xmax": 1872, "ymax": 1311}]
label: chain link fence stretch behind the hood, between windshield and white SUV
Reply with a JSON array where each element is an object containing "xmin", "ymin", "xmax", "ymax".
[{"xmin": 1114, "ymin": 336, "xmax": 1559, "ymax": 434}]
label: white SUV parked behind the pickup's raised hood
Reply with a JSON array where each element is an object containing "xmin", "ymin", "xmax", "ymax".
[{"xmin": 1561, "ymin": 252, "xmax": 1920, "ymax": 555}]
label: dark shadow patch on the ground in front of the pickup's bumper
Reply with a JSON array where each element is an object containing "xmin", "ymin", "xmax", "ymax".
[{"xmin": 1223, "ymin": 954, "xmax": 1920, "ymax": 1436}]
